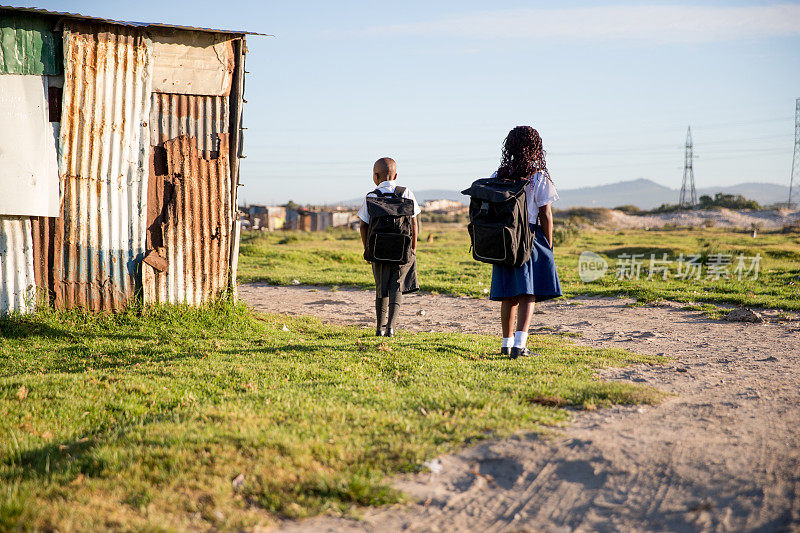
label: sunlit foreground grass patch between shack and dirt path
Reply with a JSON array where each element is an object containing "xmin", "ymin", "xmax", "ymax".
[{"xmin": 0, "ymin": 302, "xmax": 660, "ymax": 530}]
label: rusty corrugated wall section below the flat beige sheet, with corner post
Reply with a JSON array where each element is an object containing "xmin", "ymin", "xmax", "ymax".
[{"xmin": 143, "ymin": 35, "xmax": 243, "ymax": 305}]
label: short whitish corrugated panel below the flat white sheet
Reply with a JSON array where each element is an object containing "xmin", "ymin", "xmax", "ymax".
[{"xmin": 0, "ymin": 217, "xmax": 36, "ymax": 314}]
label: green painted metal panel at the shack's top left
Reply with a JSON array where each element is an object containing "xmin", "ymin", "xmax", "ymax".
[{"xmin": 0, "ymin": 11, "xmax": 64, "ymax": 76}]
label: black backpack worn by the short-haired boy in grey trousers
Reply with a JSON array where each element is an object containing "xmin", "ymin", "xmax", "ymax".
[{"xmin": 364, "ymin": 187, "xmax": 414, "ymax": 265}]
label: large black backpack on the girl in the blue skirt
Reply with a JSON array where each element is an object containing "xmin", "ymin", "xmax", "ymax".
[{"xmin": 461, "ymin": 178, "xmax": 535, "ymax": 267}]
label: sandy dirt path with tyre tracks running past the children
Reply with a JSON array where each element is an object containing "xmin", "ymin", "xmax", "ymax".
[{"xmin": 240, "ymin": 284, "xmax": 800, "ymax": 531}]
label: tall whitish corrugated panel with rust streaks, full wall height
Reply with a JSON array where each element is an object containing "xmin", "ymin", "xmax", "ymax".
[{"xmin": 55, "ymin": 20, "xmax": 152, "ymax": 311}]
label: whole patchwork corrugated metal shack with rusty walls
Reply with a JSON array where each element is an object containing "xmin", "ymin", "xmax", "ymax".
[{"xmin": 0, "ymin": 6, "xmax": 260, "ymax": 313}]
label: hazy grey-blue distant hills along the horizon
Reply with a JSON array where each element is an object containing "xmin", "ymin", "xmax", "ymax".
[{"xmin": 340, "ymin": 178, "xmax": 800, "ymax": 209}]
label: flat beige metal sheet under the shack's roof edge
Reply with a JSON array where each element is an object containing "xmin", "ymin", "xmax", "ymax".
[{"xmin": 150, "ymin": 31, "xmax": 234, "ymax": 96}]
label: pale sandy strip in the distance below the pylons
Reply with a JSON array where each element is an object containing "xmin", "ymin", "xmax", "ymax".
[{"xmin": 610, "ymin": 209, "xmax": 800, "ymax": 229}]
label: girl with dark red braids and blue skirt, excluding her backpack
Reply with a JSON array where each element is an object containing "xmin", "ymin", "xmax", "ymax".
[{"xmin": 489, "ymin": 126, "xmax": 561, "ymax": 359}]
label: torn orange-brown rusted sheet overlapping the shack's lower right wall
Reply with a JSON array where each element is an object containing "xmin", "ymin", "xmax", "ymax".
[{"xmin": 143, "ymin": 134, "xmax": 233, "ymax": 305}]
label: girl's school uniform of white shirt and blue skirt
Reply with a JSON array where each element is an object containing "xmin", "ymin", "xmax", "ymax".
[{"xmin": 489, "ymin": 172, "xmax": 561, "ymax": 302}]
